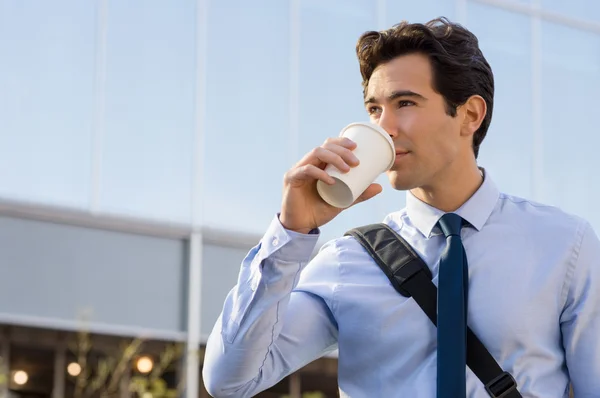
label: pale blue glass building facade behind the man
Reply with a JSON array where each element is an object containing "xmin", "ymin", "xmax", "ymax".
[{"xmin": 0, "ymin": 0, "xmax": 600, "ymax": 398}]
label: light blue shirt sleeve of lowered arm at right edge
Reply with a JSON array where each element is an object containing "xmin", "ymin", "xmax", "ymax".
[{"xmin": 561, "ymin": 219, "xmax": 600, "ymax": 398}]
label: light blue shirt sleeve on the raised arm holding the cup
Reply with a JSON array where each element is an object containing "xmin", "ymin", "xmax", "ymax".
[{"xmin": 203, "ymin": 217, "xmax": 337, "ymax": 397}]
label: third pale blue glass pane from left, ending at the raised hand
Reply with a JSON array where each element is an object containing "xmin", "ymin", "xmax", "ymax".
[{"xmin": 203, "ymin": 0, "xmax": 296, "ymax": 233}]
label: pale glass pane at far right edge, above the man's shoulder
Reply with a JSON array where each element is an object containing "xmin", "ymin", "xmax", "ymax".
[{"xmin": 541, "ymin": 23, "xmax": 600, "ymax": 229}]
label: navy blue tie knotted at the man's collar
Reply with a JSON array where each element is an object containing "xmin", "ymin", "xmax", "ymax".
[{"xmin": 437, "ymin": 213, "xmax": 468, "ymax": 398}]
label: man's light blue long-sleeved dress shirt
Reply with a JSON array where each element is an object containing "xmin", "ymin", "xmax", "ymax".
[{"xmin": 203, "ymin": 173, "xmax": 600, "ymax": 398}]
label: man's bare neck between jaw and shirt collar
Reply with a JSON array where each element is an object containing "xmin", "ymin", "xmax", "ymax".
[{"xmin": 411, "ymin": 158, "xmax": 483, "ymax": 213}]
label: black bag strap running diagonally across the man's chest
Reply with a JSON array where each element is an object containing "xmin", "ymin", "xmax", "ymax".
[{"xmin": 345, "ymin": 224, "xmax": 521, "ymax": 398}]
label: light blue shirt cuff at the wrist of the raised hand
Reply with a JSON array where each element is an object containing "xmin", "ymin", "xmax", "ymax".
[{"xmin": 261, "ymin": 214, "xmax": 320, "ymax": 262}]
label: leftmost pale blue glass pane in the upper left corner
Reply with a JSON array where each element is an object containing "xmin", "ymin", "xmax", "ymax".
[{"xmin": 0, "ymin": 0, "xmax": 95, "ymax": 208}]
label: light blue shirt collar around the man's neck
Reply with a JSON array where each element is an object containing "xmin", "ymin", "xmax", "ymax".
[{"xmin": 406, "ymin": 168, "xmax": 500, "ymax": 237}]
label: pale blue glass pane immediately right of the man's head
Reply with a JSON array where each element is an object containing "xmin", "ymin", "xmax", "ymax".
[{"xmin": 467, "ymin": 3, "xmax": 533, "ymax": 197}]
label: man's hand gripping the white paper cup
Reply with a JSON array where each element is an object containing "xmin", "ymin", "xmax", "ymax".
[{"xmin": 279, "ymin": 137, "xmax": 382, "ymax": 233}]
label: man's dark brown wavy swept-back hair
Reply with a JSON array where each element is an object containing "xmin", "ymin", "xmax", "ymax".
[{"xmin": 356, "ymin": 18, "xmax": 494, "ymax": 157}]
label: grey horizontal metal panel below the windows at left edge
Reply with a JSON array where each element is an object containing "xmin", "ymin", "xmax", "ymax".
[{"xmin": 0, "ymin": 217, "xmax": 187, "ymax": 338}]
